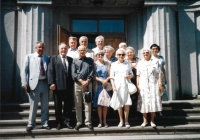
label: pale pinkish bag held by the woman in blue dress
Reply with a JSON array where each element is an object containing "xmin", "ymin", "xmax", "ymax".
[{"xmin": 97, "ymin": 88, "xmax": 110, "ymax": 107}]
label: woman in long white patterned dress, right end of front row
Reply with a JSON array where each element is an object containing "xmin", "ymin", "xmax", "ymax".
[{"xmin": 137, "ymin": 48, "xmax": 163, "ymax": 127}]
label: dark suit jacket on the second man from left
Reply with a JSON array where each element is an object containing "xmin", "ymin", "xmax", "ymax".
[{"xmin": 48, "ymin": 55, "xmax": 74, "ymax": 90}]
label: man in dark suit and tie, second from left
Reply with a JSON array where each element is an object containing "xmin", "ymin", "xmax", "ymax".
[{"xmin": 48, "ymin": 43, "xmax": 74, "ymax": 130}]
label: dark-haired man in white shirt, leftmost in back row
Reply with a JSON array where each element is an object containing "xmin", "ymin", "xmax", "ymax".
[{"xmin": 67, "ymin": 36, "xmax": 77, "ymax": 58}]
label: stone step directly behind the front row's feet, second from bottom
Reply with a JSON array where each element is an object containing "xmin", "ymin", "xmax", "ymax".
[{"xmin": 0, "ymin": 116, "xmax": 200, "ymax": 129}]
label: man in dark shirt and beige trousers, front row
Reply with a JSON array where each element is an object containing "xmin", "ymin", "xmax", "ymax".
[{"xmin": 72, "ymin": 45, "xmax": 95, "ymax": 130}]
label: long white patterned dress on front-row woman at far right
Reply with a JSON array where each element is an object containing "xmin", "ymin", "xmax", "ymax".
[{"xmin": 137, "ymin": 59, "xmax": 162, "ymax": 113}]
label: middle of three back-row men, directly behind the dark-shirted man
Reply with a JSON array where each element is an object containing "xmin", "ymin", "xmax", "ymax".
[{"xmin": 75, "ymin": 36, "xmax": 95, "ymax": 59}]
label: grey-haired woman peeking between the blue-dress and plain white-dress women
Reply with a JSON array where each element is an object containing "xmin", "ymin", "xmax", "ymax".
[{"xmin": 103, "ymin": 45, "xmax": 117, "ymax": 64}]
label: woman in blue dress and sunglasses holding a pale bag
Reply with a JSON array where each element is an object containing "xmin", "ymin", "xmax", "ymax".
[{"xmin": 93, "ymin": 50, "xmax": 110, "ymax": 128}]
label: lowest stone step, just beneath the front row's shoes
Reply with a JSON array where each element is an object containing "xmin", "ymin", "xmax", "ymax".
[{"xmin": 0, "ymin": 124, "xmax": 200, "ymax": 139}]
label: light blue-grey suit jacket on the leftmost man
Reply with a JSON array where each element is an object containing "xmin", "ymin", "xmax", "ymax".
[{"xmin": 21, "ymin": 53, "xmax": 49, "ymax": 90}]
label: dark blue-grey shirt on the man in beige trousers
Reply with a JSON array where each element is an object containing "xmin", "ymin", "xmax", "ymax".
[{"xmin": 72, "ymin": 57, "xmax": 95, "ymax": 81}]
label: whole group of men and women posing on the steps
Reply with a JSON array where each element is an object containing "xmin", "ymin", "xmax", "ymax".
[{"xmin": 21, "ymin": 36, "xmax": 168, "ymax": 132}]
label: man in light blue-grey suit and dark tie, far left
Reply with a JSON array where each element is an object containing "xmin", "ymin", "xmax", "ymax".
[{"xmin": 21, "ymin": 42, "xmax": 51, "ymax": 132}]
